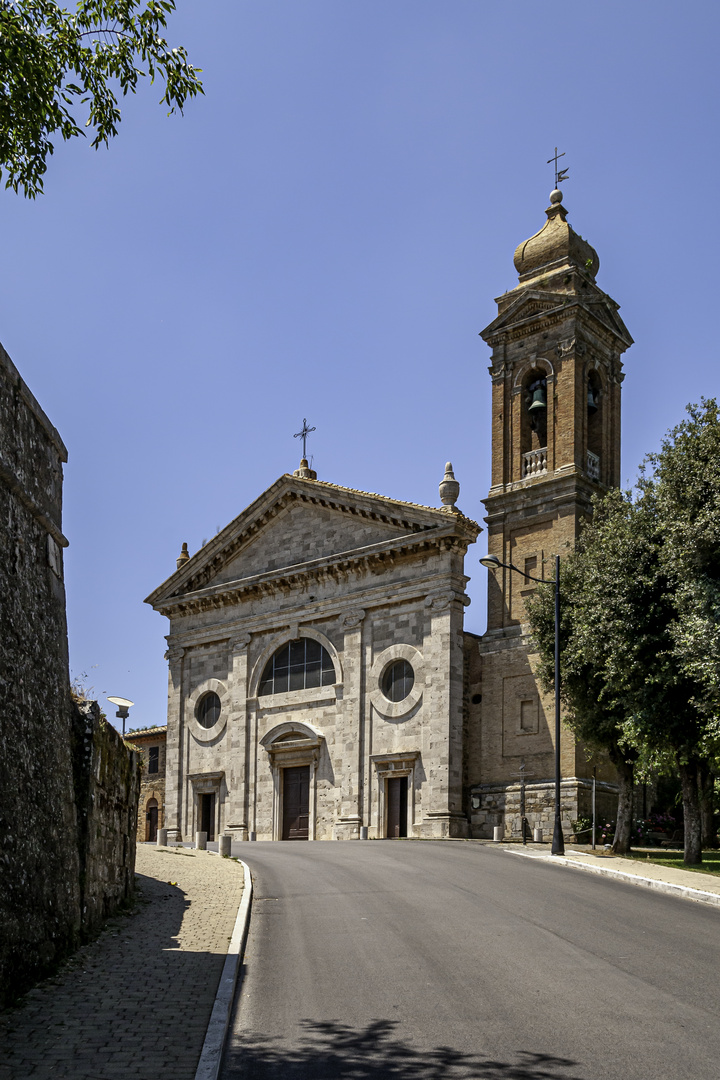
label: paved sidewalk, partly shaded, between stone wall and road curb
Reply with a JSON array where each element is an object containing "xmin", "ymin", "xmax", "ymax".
[{"xmin": 0, "ymin": 845, "xmax": 243, "ymax": 1080}]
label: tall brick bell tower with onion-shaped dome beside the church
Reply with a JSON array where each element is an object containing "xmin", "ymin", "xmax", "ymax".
[{"xmin": 471, "ymin": 190, "xmax": 633, "ymax": 835}]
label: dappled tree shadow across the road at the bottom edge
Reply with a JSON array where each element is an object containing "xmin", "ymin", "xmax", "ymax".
[{"xmin": 222, "ymin": 1020, "xmax": 581, "ymax": 1080}]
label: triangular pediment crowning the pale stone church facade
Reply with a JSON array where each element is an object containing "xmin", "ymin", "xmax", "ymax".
[{"xmin": 146, "ymin": 474, "xmax": 478, "ymax": 607}]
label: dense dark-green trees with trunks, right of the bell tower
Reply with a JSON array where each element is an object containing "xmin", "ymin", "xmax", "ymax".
[{"xmin": 529, "ymin": 401, "xmax": 720, "ymax": 863}]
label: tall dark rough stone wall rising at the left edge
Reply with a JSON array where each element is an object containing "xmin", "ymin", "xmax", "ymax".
[{"xmin": 0, "ymin": 346, "xmax": 140, "ymax": 1008}]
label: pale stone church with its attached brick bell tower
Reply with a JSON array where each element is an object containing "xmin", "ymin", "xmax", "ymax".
[{"xmin": 147, "ymin": 191, "xmax": 631, "ymax": 840}]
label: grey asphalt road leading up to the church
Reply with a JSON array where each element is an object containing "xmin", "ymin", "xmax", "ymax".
[{"xmin": 222, "ymin": 840, "xmax": 720, "ymax": 1080}]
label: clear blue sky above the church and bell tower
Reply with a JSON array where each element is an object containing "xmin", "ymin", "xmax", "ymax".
[{"xmin": 0, "ymin": 0, "xmax": 720, "ymax": 726}]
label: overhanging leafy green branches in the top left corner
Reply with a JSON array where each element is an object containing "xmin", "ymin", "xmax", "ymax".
[{"xmin": 0, "ymin": 0, "xmax": 203, "ymax": 199}]
